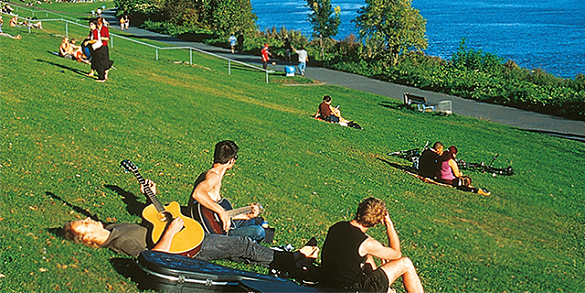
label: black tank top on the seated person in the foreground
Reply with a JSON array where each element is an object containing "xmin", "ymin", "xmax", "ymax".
[{"xmin": 321, "ymin": 222, "xmax": 368, "ymax": 288}]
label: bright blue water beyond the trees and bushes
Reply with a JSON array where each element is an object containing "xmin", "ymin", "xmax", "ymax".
[{"xmin": 251, "ymin": 0, "xmax": 585, "ymax": 78}]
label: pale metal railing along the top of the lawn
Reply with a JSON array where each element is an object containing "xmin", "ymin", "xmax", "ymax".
[{"xmin": 0, "ymin": 1, "xmax": 274, "ymax": 83}]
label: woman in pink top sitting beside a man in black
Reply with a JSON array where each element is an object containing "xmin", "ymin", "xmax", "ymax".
[{"xmin": 436, "ymin": 146, "xmax": 491, "ymax": 196}]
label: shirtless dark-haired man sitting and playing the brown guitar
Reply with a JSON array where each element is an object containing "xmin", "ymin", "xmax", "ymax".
[{"xmin": 189, "ymin": 140, "xmax": 265, "ymax": 241}]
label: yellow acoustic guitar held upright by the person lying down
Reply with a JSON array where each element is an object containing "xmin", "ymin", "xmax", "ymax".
[{"xmin": 121, "ymin": 160, "xmax": 205, "ymax": 257}]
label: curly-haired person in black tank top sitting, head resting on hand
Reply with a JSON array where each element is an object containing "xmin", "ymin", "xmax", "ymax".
[{"xmin": 320, "ymin": 197, "xmax": 424, "ymax": 293}]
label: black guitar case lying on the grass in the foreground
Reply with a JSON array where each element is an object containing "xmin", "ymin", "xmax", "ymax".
[{"xmin": 136, "ymin": 250, "xmax": 306, "ymax": 292}]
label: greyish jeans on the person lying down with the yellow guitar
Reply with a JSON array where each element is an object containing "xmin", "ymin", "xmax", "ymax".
[{"xmin": 195, "ymin": 234, "xmax": 274, "ymax": 266}]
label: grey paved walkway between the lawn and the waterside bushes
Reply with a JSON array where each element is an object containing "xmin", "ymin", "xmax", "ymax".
[{"xmin": 104, "ymin": 11, "xmax": 585, "ymax": 142}]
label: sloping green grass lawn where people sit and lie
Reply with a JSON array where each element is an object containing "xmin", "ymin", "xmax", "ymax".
[{"xmin": 0, "ymin": 10, "xmax": 585, "ymax": 292}]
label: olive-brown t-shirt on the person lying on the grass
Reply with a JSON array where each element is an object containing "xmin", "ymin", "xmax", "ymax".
[{"xmin": 102, "ymin": 223, "xmax": 149, "ymax": 257}]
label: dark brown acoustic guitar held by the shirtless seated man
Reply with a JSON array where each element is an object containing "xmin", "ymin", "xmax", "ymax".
[{"xmin": 191, "ymin": 198, "xmax": 264, "ymax": 235}]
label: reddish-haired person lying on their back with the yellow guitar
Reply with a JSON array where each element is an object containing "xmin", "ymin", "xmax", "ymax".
[{"xmin": 63, "ymin": 217, "xmax": 318, "ymax": 277}]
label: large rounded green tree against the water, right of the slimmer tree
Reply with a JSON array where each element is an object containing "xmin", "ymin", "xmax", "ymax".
[{"xmin": 353, "ymin": 0, "xmax": 428, "ymax": 65}]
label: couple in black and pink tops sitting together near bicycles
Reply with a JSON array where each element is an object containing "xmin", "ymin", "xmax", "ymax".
[{"xmin": 419, "ymin": 141, "xmax": 491, "ymax": 196}]
